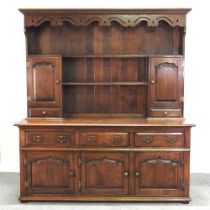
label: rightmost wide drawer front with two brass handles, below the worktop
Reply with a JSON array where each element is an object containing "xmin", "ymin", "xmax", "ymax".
[{"xmin": 135, "ymin": 133, "xmax": 184, "ymax": 147}]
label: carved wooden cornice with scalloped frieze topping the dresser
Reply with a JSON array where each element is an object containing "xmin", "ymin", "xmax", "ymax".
[{"xmin": 20, "ymin": 9, "xmax": 190, "ymax": 27}]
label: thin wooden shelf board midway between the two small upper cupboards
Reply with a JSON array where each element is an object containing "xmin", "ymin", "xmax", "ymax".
[{"xmin": 62, "ymin": 82, "xmax": 148, "ymax": 86}]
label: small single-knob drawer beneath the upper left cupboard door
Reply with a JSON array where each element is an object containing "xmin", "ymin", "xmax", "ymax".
[{"xmin": 29, "ymin": 108, "xmax": 61, "ymax": 117}]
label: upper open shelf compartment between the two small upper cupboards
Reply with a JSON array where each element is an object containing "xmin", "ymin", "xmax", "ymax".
[{"xmin": 63, "ymin": 57, "xmax": 147, "ymax": 85}]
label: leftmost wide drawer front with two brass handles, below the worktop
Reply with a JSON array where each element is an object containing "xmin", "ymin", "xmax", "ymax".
[{"xmin": 26, "ymin": 131, "xmax": 74, "ymax": 147}]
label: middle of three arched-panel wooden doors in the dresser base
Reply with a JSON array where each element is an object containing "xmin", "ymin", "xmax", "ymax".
[{"xmin": 80, "ymin": 152, "xmax": 129, "ymax": 196}]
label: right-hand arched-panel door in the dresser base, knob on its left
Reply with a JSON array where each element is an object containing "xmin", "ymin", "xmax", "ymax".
[{"xmin": 135, "ymin": 152, "xmax": 186, "ymax": 196}]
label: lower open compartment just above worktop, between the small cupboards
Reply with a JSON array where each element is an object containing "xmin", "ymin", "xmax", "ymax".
[{"xmin": 63, "ymin": 85, "xmax": 147, "ymax": 117}]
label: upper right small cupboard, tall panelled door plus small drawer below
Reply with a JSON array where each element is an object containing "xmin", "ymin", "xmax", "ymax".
[{"xmin": 148, "ymin": 57, "xmax": 183, "ymax": 117}]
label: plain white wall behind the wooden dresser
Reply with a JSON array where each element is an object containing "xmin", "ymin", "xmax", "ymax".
[{"xmin": 0, "ymin": 0, "xmax": 210, "ymax": 173}]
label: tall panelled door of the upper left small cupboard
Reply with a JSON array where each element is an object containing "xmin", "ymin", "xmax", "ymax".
[{"xmin": 27, "ymin": 56, "xmax": 62, "ymax": 107}]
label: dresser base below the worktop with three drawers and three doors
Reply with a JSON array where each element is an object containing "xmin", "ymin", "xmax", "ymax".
[{"xmin": 20, "ymin": 126, "xmax": 190, "ymax": 202}]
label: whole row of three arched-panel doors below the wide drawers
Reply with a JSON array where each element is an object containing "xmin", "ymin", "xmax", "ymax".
[{"xmin": 23, "ymin": 151, "xmax": 189, "ymax": 197}]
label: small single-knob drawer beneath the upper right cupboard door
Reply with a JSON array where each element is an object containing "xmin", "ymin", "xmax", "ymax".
[{"xmin": 149, "ymin": 109, "xmax": 182, "ymax": 117}]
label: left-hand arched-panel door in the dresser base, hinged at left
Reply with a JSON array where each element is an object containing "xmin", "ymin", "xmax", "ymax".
[{"xmin": 24, "ymin": 152, "xmax": 75, "ymax": 194}]
